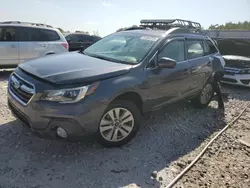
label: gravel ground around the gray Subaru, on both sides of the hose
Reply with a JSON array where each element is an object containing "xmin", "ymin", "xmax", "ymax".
[{"xmin": 0, "ymin": 71, "xmax": 250, "ymax": 188}]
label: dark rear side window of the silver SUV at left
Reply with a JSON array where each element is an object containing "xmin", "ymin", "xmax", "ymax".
[{"xmin": 20, "ymin": 28, "xmax": 60, "ymax": 41}]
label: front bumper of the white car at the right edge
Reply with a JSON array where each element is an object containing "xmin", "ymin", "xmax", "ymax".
[{"xmin": 221, "ymin": 74, "xmax": 250, "ymax": 87}]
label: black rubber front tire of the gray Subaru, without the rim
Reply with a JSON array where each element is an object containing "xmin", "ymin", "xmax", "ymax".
[{"xmin": 97, "ymin": 100, "xmax": 141, "ymax": 147}]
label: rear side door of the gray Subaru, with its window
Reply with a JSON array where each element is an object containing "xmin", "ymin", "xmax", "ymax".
[{"xmin": 187, "ymin": 38, "xmax": 212, "ymax": 95}]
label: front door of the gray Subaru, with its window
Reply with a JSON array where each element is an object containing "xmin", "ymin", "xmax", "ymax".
[{"xmin": 147, "ymin": 38, "xmax": 190, "ymax": 110}]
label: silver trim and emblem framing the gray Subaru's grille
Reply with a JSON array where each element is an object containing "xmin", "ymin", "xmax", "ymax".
[{"xmin": 8, "ymin": 73, "xmax": 35, "ymax": 106}]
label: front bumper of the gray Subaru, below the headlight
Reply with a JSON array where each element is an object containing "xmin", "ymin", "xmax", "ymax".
[{"xmin": 8, "ymin": 85, "xmax": 107, "ymax": 140}]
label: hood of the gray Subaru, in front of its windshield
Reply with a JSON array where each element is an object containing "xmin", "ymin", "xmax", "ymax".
[{"xmin": 18, "ymin": 52, "xmax": 132, "ymax": 84}]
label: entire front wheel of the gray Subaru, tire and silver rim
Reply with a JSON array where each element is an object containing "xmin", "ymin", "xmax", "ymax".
[{"xmin": 97, "ymin": 100, "xmax": 141, "ymax": 147}]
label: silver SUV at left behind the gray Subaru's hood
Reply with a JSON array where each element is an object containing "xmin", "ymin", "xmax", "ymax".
[{"xmin": 0, "ymin": 21, "xmax": 69, "ymax": 68}]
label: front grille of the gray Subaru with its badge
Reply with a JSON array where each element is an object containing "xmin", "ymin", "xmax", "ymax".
[{"xmin": 9, "ymin": 74, "xmax": 35, "ymax": 104}]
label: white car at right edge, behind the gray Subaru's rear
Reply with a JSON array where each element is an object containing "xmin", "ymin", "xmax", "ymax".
[{"xmin": 222, "ymin": 55, "xmax": 250, "ymax": 87}]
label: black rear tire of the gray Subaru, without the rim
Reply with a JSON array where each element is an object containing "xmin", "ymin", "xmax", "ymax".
[{"xmin": 191, "ymin": 83, "xmax": 214, "ymax": 109}]
